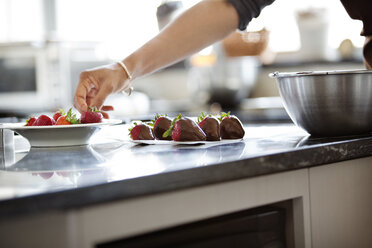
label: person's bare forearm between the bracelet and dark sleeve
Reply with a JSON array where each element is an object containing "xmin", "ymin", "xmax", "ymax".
[{"xmin": 124, "ymin": 0, "xmax": 239, "ymax": 78}]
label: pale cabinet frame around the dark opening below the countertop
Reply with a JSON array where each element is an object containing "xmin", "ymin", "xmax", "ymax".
[{"xmin": 0, "ymin": 169, "xmax": 311, "ymax": 248}]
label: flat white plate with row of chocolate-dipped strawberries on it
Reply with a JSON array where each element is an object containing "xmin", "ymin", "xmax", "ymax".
[{"xmin": 129, "ymin": 112, "xmax": 245, "ymax": 145}]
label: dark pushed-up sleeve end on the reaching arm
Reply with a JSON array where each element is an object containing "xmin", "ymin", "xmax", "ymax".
[{"xmin": 227, "ymin": 0, "xmax": 275, "ymax": 30}]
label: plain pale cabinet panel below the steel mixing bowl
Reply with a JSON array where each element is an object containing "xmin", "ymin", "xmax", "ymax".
[{"xmin": 309, "ymin": 157, "xmax": 372, "ymax": 248}]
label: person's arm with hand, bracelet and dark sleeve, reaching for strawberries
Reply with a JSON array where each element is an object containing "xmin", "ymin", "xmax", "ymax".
[{"xmin": 74, "ymin": 0, "xmax": 273, "ymax": 116}]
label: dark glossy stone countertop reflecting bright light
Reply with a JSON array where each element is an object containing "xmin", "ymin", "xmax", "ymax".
[{"xmin": 0, "ymin": 124, "xmax": 372, "ymax": 219}]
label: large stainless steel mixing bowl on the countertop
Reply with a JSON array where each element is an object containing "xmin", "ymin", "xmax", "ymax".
[{"xmin": 270, "ymin": 70, "xmax": 372, "ymax": 136}]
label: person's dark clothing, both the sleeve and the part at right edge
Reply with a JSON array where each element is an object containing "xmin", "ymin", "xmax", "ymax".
[{"xmin": 227, "ymin": 0, "xmax": 372, "ymax": 67}]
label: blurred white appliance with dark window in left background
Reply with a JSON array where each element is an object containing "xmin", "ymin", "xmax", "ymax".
[{"xmin": 0, "ymin": 42, "xmax": 61, "ymax": 112}]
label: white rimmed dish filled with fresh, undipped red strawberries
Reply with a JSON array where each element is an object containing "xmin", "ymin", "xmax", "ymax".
[{"xmin": 0, "ymin": 108, "xmax": 122, "ymax": 147}]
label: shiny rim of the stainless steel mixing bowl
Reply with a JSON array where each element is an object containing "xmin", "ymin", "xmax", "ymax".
[{"xmin": 269, "ymin": 69, "xmax": 372, "ymax": 78}]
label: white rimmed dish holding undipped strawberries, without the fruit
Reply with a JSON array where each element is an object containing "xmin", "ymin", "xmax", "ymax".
[{"xmin": 0, "ymin": 119, "xmax": 122, "ymax": 147}]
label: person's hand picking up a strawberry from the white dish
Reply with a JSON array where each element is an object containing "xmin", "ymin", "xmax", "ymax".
[{"xmin": 74, "ymin": 64, "xmax": 130, "ymax": 118}]
